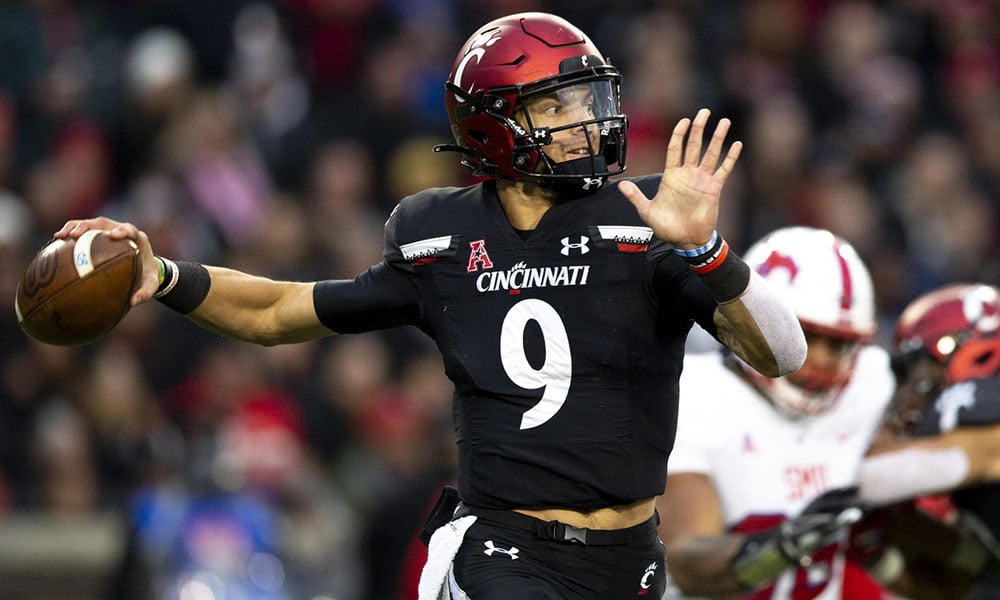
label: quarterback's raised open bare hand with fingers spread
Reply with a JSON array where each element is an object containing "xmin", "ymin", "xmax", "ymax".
[{"xmin": 618, "ymin": 108, "xmax": 743, "ymax": 249}]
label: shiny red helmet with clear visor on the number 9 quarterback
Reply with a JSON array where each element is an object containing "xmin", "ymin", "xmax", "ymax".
[{"xmin": 435, "ymin": 12, "xmax": 628, "ymax": 193}]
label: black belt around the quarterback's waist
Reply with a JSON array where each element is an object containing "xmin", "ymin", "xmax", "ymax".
[{"xmin": 455, "ymin": 503, "xmax": 660, "ymax": 546}]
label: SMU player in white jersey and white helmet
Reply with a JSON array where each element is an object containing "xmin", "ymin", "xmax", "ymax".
[{"xmin": 659, "ymin": 227, "xmax": 893, "ymax": 600}]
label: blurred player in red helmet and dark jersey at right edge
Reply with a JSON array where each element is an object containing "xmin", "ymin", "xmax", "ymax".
[{"xmin": 859, "ymin": 283, "xmax": 1000, "ymax": 599}]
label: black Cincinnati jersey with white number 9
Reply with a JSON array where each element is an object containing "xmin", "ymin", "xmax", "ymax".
[{"xmin": 315, "ymin": 176, "xmax": 717, "ymax": 509}]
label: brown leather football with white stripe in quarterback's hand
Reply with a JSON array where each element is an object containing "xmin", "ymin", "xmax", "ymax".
[{"xmin": 14, "ymin": 230, "xmax": 142, "ymax": 346}]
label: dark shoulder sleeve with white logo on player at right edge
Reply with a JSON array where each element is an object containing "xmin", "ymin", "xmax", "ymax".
[{"xmin": 916, "ymin": 378, "xmax": 1000, "ymax": 436}]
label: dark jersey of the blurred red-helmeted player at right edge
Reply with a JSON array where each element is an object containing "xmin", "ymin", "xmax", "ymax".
[{"xmin": 915, "ymin": 378, "xmax": 1000, "ymax": 538}]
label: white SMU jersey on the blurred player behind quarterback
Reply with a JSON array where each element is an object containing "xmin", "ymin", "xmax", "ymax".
[{"xmin": 668, "ymin": 345, "xmax": 895, "ymax": 600}]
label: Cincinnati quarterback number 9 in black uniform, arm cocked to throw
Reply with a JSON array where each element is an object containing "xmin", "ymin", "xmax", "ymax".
[{"xmin": 57, "ymin": 13, "xmax": 805, "ymax": 600}]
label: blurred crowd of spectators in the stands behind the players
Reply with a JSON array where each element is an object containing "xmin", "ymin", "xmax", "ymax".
[{"xmin": 0, "ymin": 0, "xmax": 1000, "ymax": 600}]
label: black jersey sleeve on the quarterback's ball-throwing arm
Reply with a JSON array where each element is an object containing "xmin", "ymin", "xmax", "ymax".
[{"xmin": 313, "ymin": 202, "xmax": 420, "ymax": 333}]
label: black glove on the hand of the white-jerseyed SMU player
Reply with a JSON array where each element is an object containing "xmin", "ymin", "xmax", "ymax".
[{"xmin": 729, "ymin": 487, "xmax": 864, "ymax": 589}]
